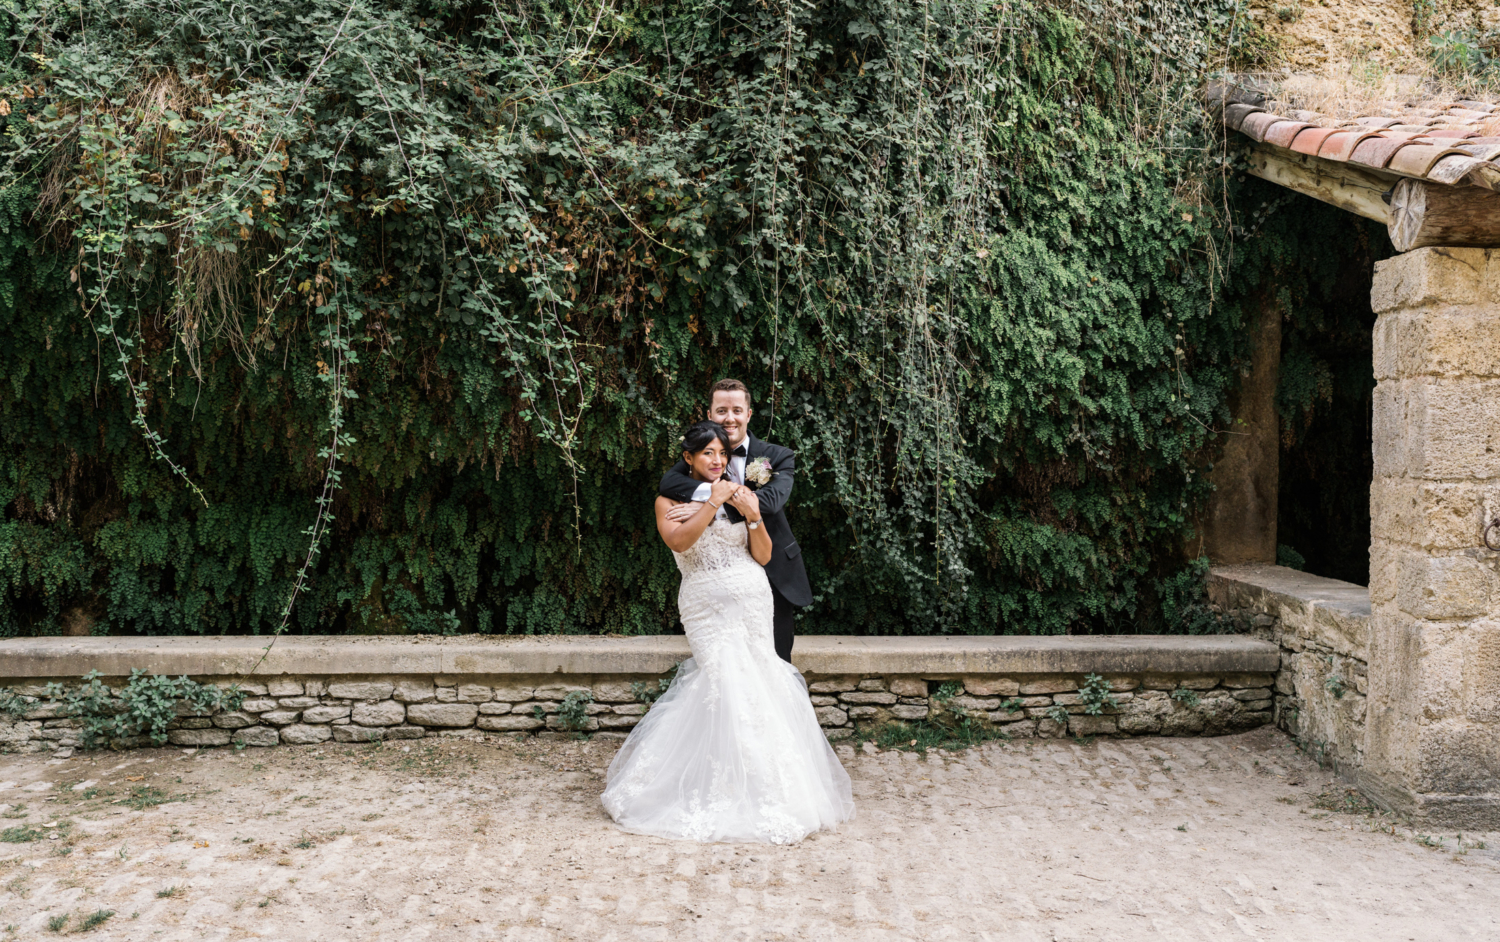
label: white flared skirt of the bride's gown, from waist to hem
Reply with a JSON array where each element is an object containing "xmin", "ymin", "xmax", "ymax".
[{"xmin": 603, "ymin": 567, "xmax": 854, "ymax": 845}]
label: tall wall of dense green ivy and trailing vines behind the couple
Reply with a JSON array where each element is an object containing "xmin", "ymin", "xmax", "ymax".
[{"xmin": 0, "ymin": 0, "xmax": 1362, "ymax": 635}]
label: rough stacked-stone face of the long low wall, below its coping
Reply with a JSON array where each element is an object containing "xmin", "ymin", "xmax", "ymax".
[{"xmin": 0, "ymin": 674, "xmax": 1274, "ymax": 752}]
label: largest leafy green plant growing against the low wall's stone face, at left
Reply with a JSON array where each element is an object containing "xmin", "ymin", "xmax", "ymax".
[{"xmin": 47, "ymin": 669, "xmax": 245, "ymax": 749}]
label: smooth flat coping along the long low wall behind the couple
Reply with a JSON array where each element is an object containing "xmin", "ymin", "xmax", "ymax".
[{"xmin": 0, "ymin": 633, "xmax": 1290, "ymax": 680}]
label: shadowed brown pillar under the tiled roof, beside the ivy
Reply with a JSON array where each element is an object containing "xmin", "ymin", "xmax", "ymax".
[{"xmin": 1194, "ymin": 296, "xmax": 1281, "ymax": 566}]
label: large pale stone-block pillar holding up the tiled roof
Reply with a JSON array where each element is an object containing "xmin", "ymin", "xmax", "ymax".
[{"xmin": 1358, "ymin": 248, "xmax": 1500, "ymax": 830}]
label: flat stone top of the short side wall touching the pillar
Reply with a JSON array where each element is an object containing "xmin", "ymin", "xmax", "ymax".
[{"xmin": 1209, "ymin": 566, "xmax": 1370, "ymax": 660}]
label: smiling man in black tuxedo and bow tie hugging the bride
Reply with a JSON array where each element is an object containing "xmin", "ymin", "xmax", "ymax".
[{"xmin": 659, "ymin": 380, "xmax": 813, "ymax": 663}]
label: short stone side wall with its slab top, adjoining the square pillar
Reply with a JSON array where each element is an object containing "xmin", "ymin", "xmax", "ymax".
[{"xmin": 1209, "ymin": 566, "xmax": 1370, "ymax": 776}]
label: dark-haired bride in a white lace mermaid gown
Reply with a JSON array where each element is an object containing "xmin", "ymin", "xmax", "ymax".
[{"xmin": 603, "ymin": 422, "xmax": 854, "ymax": 845}]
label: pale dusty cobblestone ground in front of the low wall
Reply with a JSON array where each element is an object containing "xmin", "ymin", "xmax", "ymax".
[{"xmin": 0, "ymin": 731, "xmax": 1500, "ymax": 942}]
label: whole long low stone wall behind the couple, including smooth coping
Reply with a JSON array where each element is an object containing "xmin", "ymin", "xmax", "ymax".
[{"xmin": 0, "ymin": 636, "xmax": 1278, "ymax": 752}]
